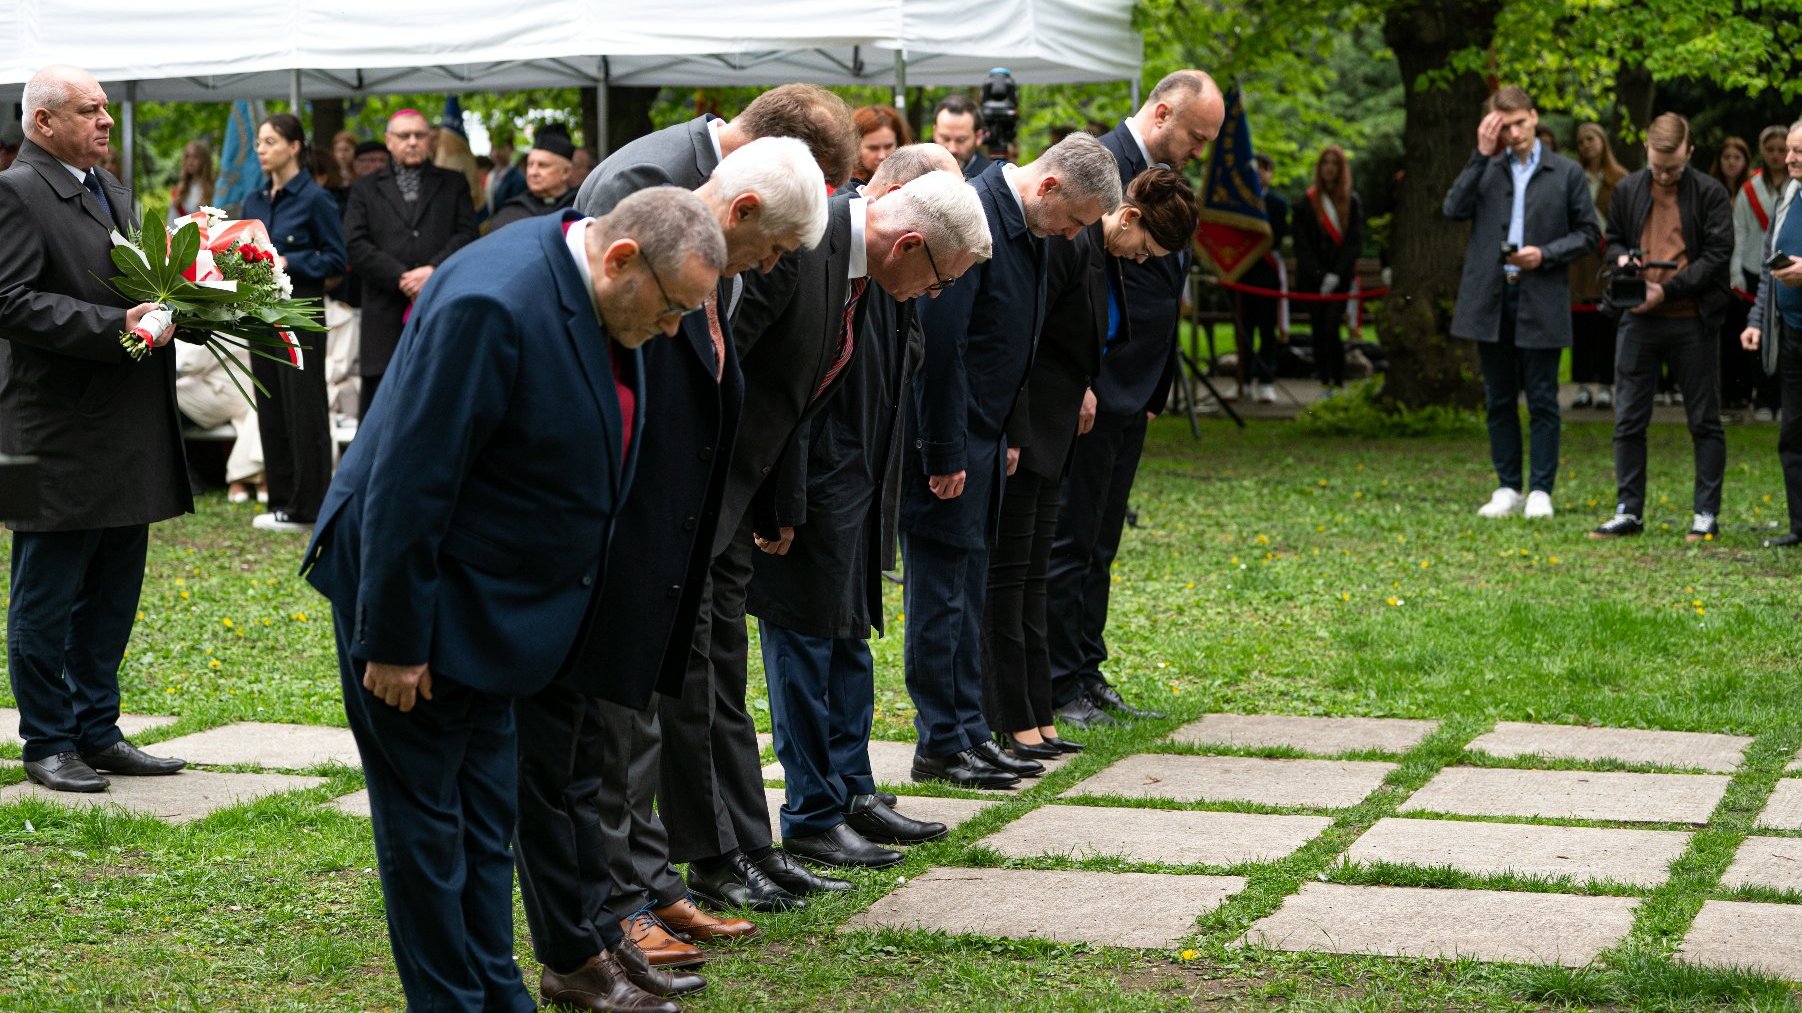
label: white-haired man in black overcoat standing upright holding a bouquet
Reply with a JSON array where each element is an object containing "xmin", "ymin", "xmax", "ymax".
[{"xmin": 0, "ymin": 67, "xmax": 195, "ymax": 791}]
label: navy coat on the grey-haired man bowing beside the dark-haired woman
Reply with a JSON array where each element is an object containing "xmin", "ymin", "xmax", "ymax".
[{"xmin": 901, "ymin": 162, "xmax": 1045, "ymax": 548}]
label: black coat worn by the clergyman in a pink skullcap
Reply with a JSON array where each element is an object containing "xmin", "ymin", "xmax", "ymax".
[{"xmin": 344, "ymin": 164, "xmax": 478, "ymax": 377}]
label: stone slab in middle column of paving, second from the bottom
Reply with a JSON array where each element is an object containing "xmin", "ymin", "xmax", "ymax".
[{"xmin": 1342, "ymin": 818, "xmax": 1693, "ymax": 887}]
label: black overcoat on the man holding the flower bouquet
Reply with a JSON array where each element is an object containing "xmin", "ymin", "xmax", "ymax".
[{"xmin": 0, "ymin": 141, "xmax": 195, "ymax": 532}]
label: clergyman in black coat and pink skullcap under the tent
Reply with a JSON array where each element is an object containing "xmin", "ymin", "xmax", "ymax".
[{"xmin": 344, "ymin": 110, "xmax": 476, "ymax": 418}]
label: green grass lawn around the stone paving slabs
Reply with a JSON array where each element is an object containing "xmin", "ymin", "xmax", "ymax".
[{"xmin": 0, "ymin": 418, "xmax": 1802, "ymax": 1011}]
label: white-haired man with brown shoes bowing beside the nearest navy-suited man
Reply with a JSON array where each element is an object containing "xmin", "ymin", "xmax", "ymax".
[{"xmin": 515, "ymin": 137, "xmax": 825, "ymax": 1006}]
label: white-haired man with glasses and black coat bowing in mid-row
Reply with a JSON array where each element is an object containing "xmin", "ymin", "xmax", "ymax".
[{"xmin": 677, "ymin": 173, "xmax": 989, "ymax": 907}]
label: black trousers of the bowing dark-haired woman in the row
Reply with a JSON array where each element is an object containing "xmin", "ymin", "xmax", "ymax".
[{"xmin": 982, "ymin": 470, "xmax": 1061, "ymax": 732}]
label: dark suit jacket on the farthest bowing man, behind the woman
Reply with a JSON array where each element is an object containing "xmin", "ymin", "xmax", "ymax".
[{"xmin": 1096, "ymin": 123, "xmax": 1189, "ymax": 415}]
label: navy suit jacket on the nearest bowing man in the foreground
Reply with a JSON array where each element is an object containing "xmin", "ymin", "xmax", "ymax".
[{"xmin": 303, "ymin": 211, "xmax": 647, "ymax": 696}]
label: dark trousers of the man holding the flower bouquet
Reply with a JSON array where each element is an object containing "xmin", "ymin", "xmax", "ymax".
[{"xmin": 5, "ymin": 525, "xmax": 150, "ymax": 761}]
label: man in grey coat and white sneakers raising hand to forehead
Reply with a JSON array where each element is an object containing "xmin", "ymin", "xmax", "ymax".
[{"xmin": 1445, "ymin": 87, "xmax": 1602, "ymax": 517}]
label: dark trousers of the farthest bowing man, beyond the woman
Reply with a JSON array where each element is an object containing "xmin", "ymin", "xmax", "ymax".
[{"xmin": 1045, "ymin": 405, "xmax": 1146, "ymax": 707}]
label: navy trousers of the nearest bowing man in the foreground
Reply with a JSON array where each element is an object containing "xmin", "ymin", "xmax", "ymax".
[{"xmin": 332, "ymin": 609, "xmax": 537, "ymax": 1013}]
